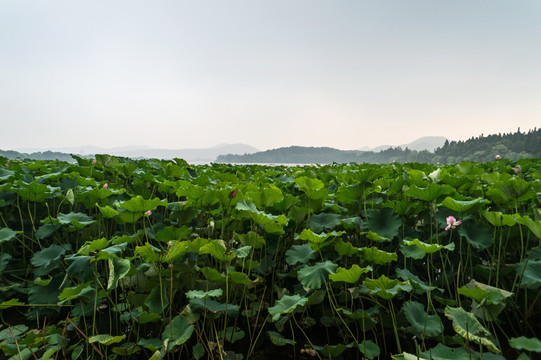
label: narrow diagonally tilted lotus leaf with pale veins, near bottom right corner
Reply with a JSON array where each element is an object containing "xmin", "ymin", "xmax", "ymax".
[{"xmin": 445, "ymin": 306, "xmax": 500, "ymax": 353}]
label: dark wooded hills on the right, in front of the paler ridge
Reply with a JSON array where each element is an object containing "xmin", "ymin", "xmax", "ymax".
[{"xmin": 217, "ymin": 129, "xmax": 541, "ymax": 164}]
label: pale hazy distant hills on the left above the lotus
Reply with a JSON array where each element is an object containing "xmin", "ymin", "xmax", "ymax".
[{"xmin": 0, "ymin": 144, "xmax": 258, "ymax": 162}]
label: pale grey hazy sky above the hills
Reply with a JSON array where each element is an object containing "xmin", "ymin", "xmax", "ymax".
[{"xmin": 0, "ymin": 0, "xmax": 541, "ymax": 150}]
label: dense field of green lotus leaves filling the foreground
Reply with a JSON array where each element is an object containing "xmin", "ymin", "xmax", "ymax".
[{"xmin": 0, "ymin": 155, "xmax": 541, "ymax": 360}]
